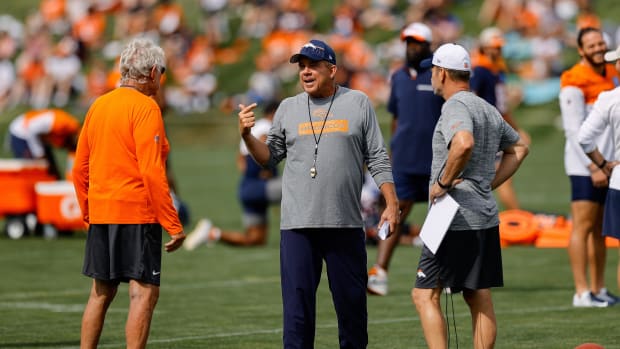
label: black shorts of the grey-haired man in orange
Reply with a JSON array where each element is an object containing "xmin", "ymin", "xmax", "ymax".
[{"xmin": 82, "ymin": 224, "xmax": 162, "ymax": 286}]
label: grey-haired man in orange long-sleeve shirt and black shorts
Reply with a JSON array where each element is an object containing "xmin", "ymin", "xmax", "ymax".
[{"xmin": 73, "ymin": 38, "xmax": 185, "ymax": 349}]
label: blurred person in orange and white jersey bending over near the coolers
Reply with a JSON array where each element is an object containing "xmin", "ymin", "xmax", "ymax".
[{"xmin": 9, "ymin": 109, "xmax": 80, "ymax": 178}]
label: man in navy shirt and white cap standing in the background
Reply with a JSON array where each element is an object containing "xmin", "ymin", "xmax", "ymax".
[{"xmin": 368, "ymin": 23, "xmax": 443, "ymax": 296}]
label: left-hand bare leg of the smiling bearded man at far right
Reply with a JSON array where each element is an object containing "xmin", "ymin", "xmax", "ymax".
[{"xmin": 568, "ymin": 201, "xmax": 599, "ymax": 294}]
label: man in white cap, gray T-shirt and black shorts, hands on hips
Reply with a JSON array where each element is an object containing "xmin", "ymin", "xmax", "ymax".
[{"xmin": 412, "ymin": 44, "xmax": 528, "ymax": 349}]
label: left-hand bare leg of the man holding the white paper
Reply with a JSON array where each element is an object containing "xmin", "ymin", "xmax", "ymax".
[{"xmin": 411, "ymin": 288, "xmax": 448, "ymax": 349}]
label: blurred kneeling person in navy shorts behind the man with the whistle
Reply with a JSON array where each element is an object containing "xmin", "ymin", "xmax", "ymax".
[{"xmin": 183, "ymin": 102, "xmax": 282, "ymax": 247}]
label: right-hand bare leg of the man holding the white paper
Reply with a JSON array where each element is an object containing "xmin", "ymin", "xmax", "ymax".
[{"xmin": 463, "ymin": 288, "xmax": 497, "ymax": 349}]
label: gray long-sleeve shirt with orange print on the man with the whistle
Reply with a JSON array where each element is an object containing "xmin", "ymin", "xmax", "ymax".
[{"xmin": 267, "ymin": 87, "xmax": 393, "ymax": 229}]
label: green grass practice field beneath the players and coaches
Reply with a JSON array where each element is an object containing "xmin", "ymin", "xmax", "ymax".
[{"xmin": 0, "ymin": 101, "xmax": 620, "ymax": 349}]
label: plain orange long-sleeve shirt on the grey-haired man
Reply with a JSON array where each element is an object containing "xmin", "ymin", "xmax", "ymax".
[{"xmin": 73, "ymin": 87, "xmax": 183, "ymax": 235}]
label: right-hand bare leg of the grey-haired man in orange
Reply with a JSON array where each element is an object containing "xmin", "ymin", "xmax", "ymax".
[{"xmin": 125, "ymin": 280, "xmax": 159, "ymax": 349}]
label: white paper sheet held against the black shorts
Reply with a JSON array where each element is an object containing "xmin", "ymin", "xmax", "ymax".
[{"xmin": 420, "ymin": 194, "xmax": 459, "ymax": 254}]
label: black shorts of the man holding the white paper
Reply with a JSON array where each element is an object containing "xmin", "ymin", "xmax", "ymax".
[{"xmin": 415, "ymin": 227, "xmax": 504, "ymax": 292}]
